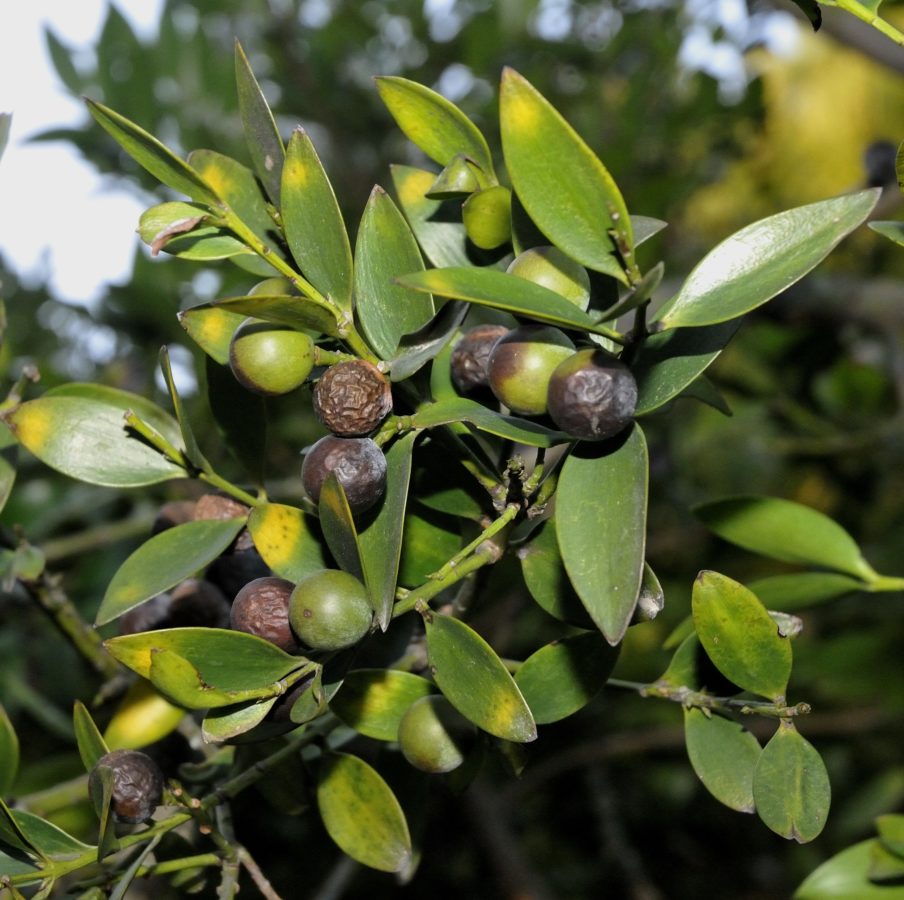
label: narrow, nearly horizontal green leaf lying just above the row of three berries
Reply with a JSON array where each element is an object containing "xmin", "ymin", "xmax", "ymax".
[{"xmin": 398, "ymin": 266, "xmax": 598, "ymax": 332}]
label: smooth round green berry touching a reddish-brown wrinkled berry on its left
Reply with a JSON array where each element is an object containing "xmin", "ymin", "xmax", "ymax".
[{"xmin": 289, "ymin": 569, "xmax": 373, "ymax": 650}]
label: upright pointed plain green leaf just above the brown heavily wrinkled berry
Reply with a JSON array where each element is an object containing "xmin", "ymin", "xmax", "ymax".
[{"xmin": 355, "ymin": 186, "xmax": 434, "ymax": 359}]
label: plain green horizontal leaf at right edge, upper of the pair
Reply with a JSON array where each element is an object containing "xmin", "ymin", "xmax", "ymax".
[{"xmin": 694, "ymin": 496, "xmax": 877, "ymax": 582}]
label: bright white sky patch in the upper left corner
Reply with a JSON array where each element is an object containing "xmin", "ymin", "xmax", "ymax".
[{"xmin": 0, "ymin": 0, "xmax": 162, "ymax": 303}]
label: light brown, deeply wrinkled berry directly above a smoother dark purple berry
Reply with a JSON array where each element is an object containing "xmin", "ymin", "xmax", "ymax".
[{"xmin": 313, "ymin": 359, "xmax": 392, "ymax": 437}]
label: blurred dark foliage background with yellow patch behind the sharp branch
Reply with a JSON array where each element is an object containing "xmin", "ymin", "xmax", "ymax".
[{"xmin": 0, "ymin": 0, "xmax": 904, "ymax": 900}]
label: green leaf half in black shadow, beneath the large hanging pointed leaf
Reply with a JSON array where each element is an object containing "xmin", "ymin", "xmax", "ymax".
[{"xmin": 515, "ymin": 632, "xmax": 618, "ymax": 725}]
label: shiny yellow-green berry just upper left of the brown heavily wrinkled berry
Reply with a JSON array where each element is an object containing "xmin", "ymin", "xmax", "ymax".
[{"xmin": 229, "ymin": 319, "xmax": 314, "ymax": 397}]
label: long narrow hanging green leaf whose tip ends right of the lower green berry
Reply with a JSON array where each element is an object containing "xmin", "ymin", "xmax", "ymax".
[{"xmin": 358, "ymin": 433, "xmax": 417, "ymax": 631}]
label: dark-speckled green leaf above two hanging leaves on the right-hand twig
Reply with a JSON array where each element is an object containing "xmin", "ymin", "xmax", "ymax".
[{"xmin": 691, "ymin": 571, "xmax": 791, "ymax": 701}]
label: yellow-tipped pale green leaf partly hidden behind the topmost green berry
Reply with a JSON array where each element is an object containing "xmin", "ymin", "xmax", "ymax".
[{"xmin": 391, "ymin": 165, "xmax": 471, "ymax": 268}]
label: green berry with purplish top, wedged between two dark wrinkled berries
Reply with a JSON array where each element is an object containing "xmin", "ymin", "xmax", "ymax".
[{"xmin": 487, "ymin": 325, "xmax": 574, "ymax": 416}]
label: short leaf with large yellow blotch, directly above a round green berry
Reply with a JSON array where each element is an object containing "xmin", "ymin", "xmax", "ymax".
[{"xmin": 248, "ymin": 503, "xmax": 327, "ymax": 582}]
